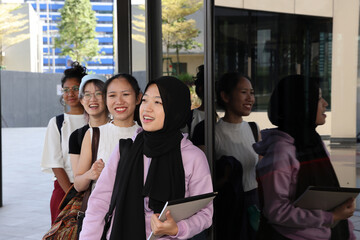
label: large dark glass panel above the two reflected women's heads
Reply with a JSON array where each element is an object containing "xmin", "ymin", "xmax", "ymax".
[{"xmin": 215, "ymin": 7, "xmax": 332, "ymax": 111}]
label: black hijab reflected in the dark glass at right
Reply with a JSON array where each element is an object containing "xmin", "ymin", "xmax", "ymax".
[{"xmin": 268, "ymin": 75, "xmax": 349, "ymax": 239}]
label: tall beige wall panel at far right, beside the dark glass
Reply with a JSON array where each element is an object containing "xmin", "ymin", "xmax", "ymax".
[{"xmin": 331, "ymin": 0, "xmax": 359, "ymax": 138}]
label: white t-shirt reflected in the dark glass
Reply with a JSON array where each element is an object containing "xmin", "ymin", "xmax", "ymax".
[{"xmin": 215, "ymin": 119, "xmax": 258, "ymax": 192}]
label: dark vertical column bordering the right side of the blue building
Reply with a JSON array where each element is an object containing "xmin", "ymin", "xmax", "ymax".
[{"xmin": 114, "ymin": 0, "xmax": 132, "ymax": 74}]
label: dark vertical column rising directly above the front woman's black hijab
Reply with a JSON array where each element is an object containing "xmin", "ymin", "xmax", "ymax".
[{"xmin": 145, "ymin": 0, "xmax": 163, "ymax": 82}]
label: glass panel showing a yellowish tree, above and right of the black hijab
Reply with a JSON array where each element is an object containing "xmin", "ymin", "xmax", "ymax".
[{"xmin": 162, "ymin": 0, "xmax": 204, "ymax": 108}]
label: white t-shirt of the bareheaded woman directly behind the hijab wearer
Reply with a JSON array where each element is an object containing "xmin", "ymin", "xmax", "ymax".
[{"xmin": 89, "ymin": 122, "xmax": 140, "ymax": 164}]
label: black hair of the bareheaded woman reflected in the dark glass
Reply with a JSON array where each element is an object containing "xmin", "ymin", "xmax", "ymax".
[{"xmin": 216, "ymin": 72, "xmax": 251, "ymax": 109}]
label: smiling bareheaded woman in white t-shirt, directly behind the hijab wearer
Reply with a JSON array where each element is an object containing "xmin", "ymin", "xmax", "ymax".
[{"xmin": 74, "ymin": 74, "xmax": 141, "ymax": 191}]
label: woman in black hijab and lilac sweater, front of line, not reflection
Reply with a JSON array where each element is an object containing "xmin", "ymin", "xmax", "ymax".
[{"xmin": 80, "ymin": 77, "xmax": 213, "ymax": 240}]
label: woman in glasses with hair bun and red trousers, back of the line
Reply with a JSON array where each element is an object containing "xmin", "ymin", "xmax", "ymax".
[{"xmin": 41, "ymin": 62, "xmax": 86, "ymax": 223}]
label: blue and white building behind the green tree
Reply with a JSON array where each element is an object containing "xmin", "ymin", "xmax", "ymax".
[{"xmin": 25, "ymin": 0, "xmax": 115, "ymax": 74}]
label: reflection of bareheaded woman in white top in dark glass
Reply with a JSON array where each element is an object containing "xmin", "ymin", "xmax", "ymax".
[{"xmin": 215, "ymin": 72, "xmax": 259, "ymax": 239}]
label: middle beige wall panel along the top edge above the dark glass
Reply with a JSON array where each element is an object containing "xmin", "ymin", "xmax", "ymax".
[{"xmin": 244, "ymin": 0, "xmax": 295, "ymax": 13}]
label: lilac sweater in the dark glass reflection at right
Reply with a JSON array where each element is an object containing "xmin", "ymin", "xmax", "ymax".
[{"xmin": 253, "ymin": 129, "xmax": 356, "ymax": 240}]
